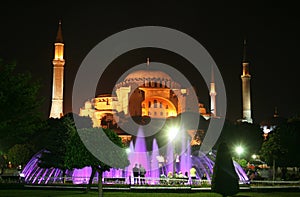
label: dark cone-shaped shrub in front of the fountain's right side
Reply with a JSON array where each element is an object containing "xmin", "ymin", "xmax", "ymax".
[{"xmin": 211, "ymin": 142, "xmax": 239, "ymax": 196}]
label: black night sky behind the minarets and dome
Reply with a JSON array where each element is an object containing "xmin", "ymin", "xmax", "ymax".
[{"xmin": 0, "ymin": 1, "xmax": 300, "ymax": 123}]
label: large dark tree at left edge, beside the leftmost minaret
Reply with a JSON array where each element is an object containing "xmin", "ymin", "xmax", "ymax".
[{"xmin": 0, "ymin": 59, "xmax": 43, "ymax": 152}]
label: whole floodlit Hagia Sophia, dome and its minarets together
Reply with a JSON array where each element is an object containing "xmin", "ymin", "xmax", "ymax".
[{"xmin": 50, "ymin": 22, "xmax": 253, "ymax": 142}]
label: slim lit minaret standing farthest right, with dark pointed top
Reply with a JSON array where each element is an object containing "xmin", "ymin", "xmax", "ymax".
[{"xmin": 241, "ymin": 40, "xmax": 253, "ymax": 123}]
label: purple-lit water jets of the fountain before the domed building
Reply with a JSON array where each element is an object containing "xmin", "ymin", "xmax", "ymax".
[{"xmin": 22, "ymin": 129, "xmax": 249, "ymax": 184}]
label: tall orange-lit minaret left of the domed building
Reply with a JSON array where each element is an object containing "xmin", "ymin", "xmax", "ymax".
[{"xmin": 50, "ymin": 21, "xmax": 65, "ymax": 118}]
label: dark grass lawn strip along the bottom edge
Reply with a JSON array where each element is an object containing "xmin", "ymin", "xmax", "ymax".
[{"xmin": 0, "ymin": 189, "xmax": 300, "ymax": 197}]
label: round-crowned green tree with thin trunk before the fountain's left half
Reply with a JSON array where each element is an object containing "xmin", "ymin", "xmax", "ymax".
[{"xmin": 66, "ymin": 128, "xmax": 129, "ymax": 197}]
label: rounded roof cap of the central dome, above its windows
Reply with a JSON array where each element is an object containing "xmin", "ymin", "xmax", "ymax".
[{"xmin": 124, "ymin": 70, "xmax": 172, "ymax": 81}]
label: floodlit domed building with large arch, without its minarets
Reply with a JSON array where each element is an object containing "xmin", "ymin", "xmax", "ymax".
[{"xmin": 79, "ymin": 67, "xmax": 210, "ymax": 127}]
